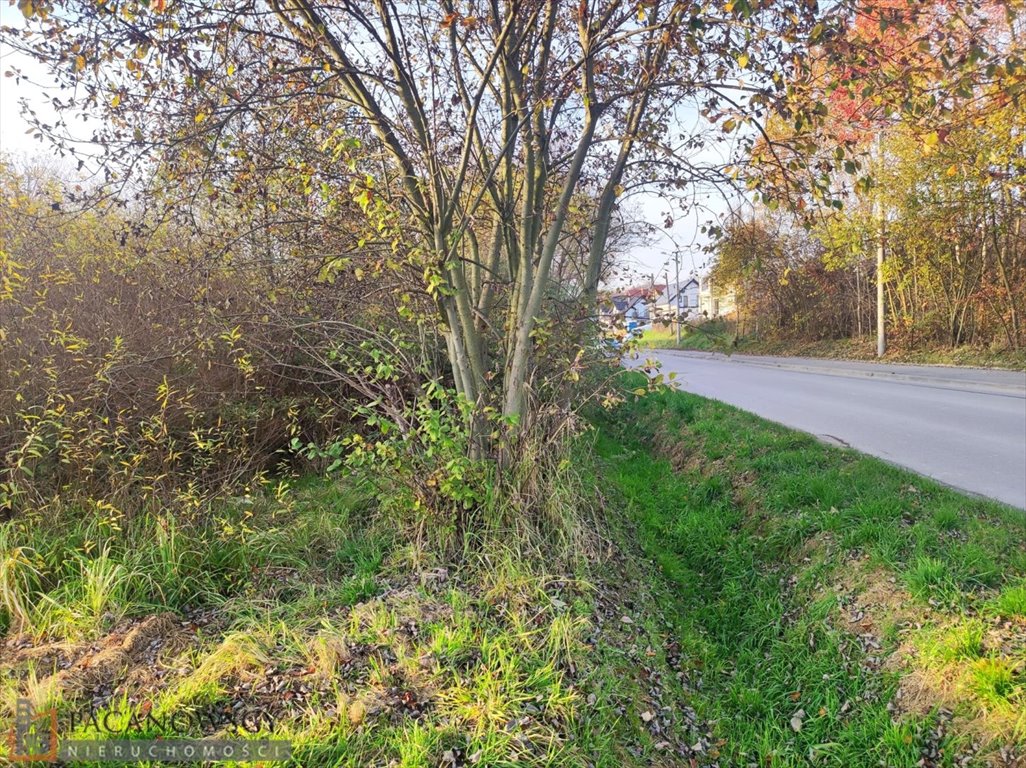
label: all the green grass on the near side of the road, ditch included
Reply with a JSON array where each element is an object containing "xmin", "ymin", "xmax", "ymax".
[{"xmin": 0, "ymin": 376, "xmax": 1026, "ymax": 768}]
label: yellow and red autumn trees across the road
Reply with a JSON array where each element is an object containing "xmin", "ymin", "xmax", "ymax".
[{"xmin": 713, "ymin": 0, "xmax": 1026, "ymax": 350}]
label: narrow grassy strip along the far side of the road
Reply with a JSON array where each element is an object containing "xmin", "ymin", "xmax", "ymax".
[{"xmin": 641, "ymin": 320, "xmax": 1026, "ymax": 370}]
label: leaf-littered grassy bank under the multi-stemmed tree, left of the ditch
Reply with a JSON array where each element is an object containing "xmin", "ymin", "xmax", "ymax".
[{"xmin": 0, "ymin": 454, "xmax": 706, "ymax": 768}]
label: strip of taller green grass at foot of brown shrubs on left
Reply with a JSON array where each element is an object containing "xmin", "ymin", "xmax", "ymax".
[{"xmin": 0, "ymin": 484, "xmax": 385, "ymax": 640}]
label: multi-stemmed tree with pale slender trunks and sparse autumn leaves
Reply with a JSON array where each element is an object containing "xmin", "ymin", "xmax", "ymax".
[{"xmin": 8, "ymin": 0, "xmax": 815, "ymax": 442}]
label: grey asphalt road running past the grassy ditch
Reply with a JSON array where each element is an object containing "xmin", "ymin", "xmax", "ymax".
[{"xmin": 642, "ymin": 350, "xmax": 1026, "ymax": 509}]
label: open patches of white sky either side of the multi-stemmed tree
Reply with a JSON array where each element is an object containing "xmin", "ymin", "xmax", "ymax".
[{"xmin": 0, "ymin": 2, "xmax": 731, "ymax": 285}]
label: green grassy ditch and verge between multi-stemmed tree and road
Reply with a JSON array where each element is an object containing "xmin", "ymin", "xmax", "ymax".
[{"xmin": 599, "ymin": 369, "xmax": 1026, "ymax": 768}]
